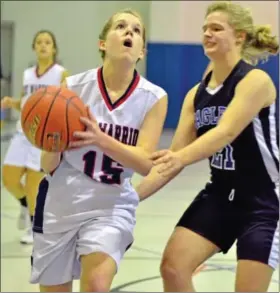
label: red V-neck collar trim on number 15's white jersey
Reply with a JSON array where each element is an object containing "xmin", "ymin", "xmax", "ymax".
[{"xmin": 97, "ymin": 67, "xmax": 140, "ymax": 111}]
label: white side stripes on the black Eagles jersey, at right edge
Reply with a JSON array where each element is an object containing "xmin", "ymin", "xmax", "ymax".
[{"xmin": 253, "ymin": 105, "xmax": 279, "ymax": 182}]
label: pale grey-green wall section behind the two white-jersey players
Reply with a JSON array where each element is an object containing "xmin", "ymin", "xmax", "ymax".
[{"xmin": 1, "ymin": 1, "xmax": 150, "ymax": 100}]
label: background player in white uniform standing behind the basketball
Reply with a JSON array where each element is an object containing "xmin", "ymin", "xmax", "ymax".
[{"xmin": 1, "ymin": 30, "xmax": 68, "ymax": 244}]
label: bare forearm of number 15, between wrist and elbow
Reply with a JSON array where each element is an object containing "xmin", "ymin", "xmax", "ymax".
[{"xmin": 98, "ymin": 134, "xmax": 152, "ymax": 176}]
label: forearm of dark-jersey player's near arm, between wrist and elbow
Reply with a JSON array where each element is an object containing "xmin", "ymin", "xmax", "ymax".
[{"xmin": 178, "ymin": 127, "xmax": 234, "ymax": 166}]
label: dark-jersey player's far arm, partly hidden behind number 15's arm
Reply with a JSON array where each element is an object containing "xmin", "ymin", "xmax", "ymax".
[{"xmin": 136, "ymin": 85, "xmax": 199, "ymax": 200}]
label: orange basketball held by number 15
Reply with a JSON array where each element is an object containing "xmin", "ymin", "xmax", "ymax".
[{"xmin": 21, "ymin": 86, "xmax": 88, "ymax": 152}]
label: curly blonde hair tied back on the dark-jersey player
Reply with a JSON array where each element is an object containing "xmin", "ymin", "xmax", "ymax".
[{"xmin": 206, "ymin": 1, "xmax": 279, "ymax": 65}]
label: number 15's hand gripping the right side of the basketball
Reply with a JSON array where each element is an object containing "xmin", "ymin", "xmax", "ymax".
[{"xmin": 69, "ymin": 107, "xmax": 103, "ymax": 148}]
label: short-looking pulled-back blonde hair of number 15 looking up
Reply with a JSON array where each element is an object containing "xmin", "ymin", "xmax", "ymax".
[{"xmin": 99, "ymin": 9, "xmax": 146, "ymax": 60}]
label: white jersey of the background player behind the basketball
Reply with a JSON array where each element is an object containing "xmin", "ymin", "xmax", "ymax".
[{"xmin": 17, "ymin": 63, "xmax": 65, "ymax": 132}]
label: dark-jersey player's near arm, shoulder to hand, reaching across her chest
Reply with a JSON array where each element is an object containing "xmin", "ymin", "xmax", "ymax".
[{"xmin": 152, "ymin": 69, "xmax": 276, "ymax": 176}]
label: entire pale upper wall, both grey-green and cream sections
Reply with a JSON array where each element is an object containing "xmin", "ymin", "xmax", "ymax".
[{"xmin": 1, "ymin": 1, "xmax": 279, "ymax": 106}]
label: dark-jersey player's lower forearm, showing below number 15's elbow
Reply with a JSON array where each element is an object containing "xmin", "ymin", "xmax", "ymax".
[{"xmin": 135, "ymin": 165, "xmax": 182, "ymax": 201}]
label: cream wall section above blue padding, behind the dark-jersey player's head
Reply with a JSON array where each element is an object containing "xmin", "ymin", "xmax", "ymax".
[{"xmin": 150, "ymin": 1, "xmax": 279, "ymax": 43}]
